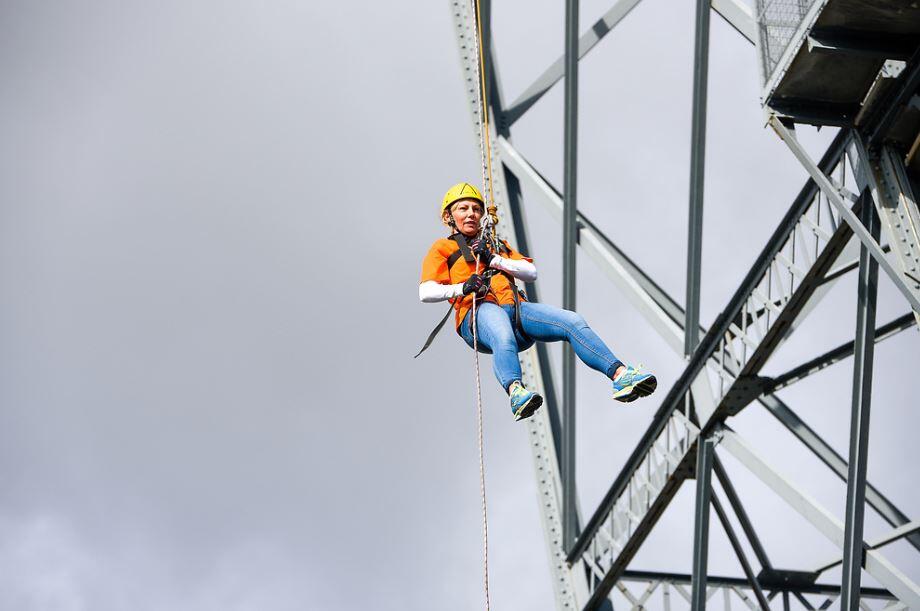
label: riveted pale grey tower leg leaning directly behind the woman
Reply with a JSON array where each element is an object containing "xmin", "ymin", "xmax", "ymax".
[{"xmin": 450, "ymin": 0, "xmax": 586, "ymax": 611}]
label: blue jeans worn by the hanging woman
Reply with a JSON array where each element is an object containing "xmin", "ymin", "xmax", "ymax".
[{"xmin": 460, "ymin": 301, "xmax": 623, "ymax": 390}]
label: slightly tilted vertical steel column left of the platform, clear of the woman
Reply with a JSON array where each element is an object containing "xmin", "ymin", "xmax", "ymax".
[{"xmin": 684, "ymin": 0, "xmax": 710, "ymax": 356}]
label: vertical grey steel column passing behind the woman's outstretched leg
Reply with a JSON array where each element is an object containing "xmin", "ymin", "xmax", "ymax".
[{"xmin": 562, "ymin": 0, "xmax": 578, "ymax": 550}]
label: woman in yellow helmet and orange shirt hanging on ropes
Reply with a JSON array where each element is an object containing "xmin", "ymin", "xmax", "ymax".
[{"xmin": 418, "ymin": 183, "xmax": 657, "ymax": 420}]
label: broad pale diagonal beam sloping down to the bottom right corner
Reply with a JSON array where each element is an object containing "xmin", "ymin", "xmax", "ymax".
[{"xmin": 721, "ymin": 430, "xmax": 920, "ymax": 608}]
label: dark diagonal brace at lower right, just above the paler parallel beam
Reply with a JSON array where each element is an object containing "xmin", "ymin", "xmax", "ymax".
[{"xmin": 760, "ymin": 395, "xmax": 920, "ymax": 550}]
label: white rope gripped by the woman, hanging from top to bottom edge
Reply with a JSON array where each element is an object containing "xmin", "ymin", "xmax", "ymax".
[{"xmin": 470, "ymin": 0, "xmax": 495, "ymax": 611}]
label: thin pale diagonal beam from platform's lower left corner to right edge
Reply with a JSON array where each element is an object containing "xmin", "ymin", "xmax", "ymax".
[{"xmin": 770, "ymin": 116, "xmax": 920, "ymax": 311}]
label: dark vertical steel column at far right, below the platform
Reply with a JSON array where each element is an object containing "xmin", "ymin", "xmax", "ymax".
[{"xmin": 840, "ymin": 192, "xmax": 880, "ymax": 611}]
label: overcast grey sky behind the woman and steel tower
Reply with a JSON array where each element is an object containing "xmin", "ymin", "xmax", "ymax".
[{"xmin": 0, "ymin": 0, "xmax": 920, "ymax": 611}]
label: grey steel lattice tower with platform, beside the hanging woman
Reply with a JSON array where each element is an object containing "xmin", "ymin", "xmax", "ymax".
[{"xmin": 450, "ymin": 0, "xmax": 920, "ymax": 610}]
